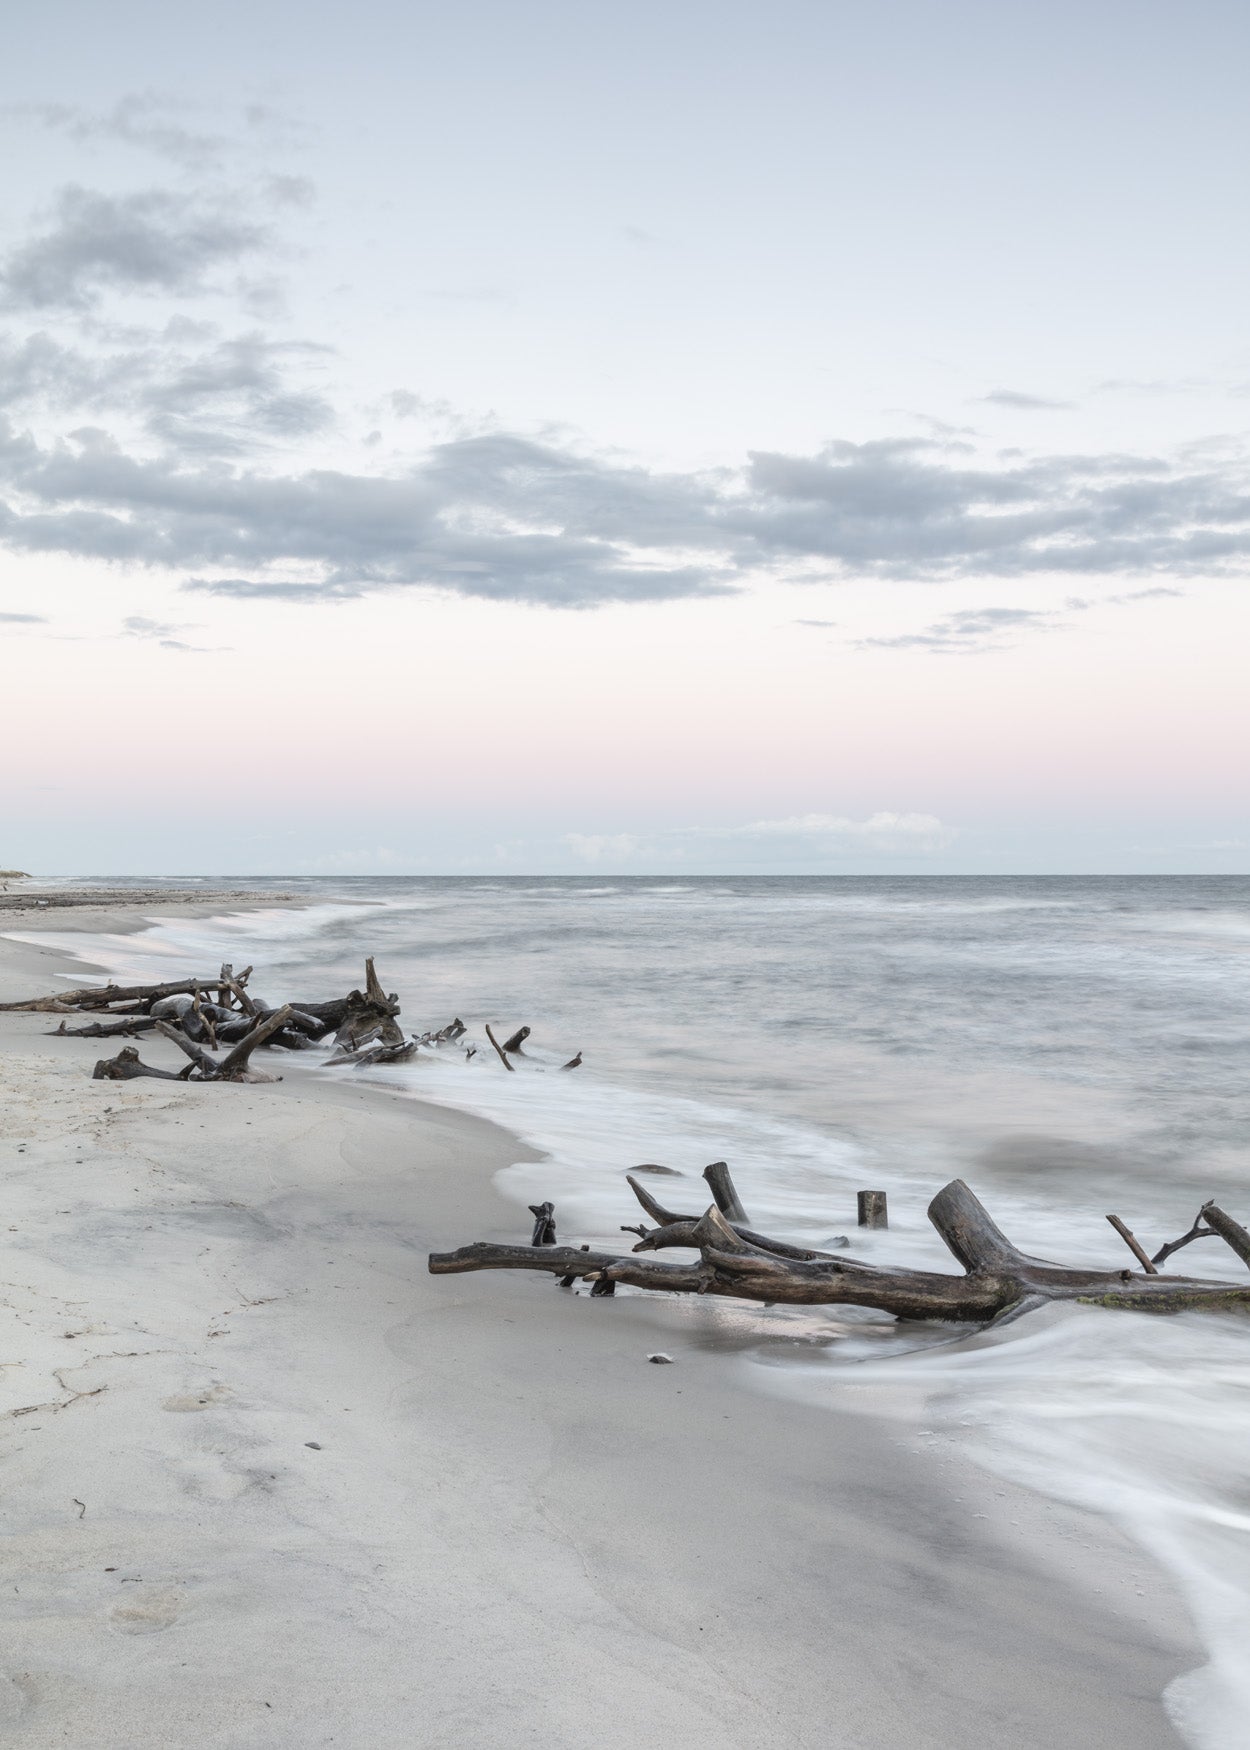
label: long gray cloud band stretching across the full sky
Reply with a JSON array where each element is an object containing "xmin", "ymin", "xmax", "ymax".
[{"xmin": 0, "ymin": 420, "xmax": 1250, "ymax": 612}]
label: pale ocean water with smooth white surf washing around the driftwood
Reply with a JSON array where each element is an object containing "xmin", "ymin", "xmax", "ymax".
[{"xmin": 17, "ymin": 877, "xmax": 1250, "ymax": 1750}]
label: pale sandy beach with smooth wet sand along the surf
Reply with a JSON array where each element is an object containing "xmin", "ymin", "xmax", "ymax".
[{"xmin": 0, "ymin": 901, "xmax": 1201, "ymax": 1750}]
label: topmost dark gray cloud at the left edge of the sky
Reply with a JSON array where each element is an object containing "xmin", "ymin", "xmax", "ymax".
[{"xmin": 0, "ymin": 184, "xmax": 268, "ymax": 310}]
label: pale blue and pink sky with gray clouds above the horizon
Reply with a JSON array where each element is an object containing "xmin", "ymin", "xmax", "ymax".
[{"xmin": 0, "ymin": 0, "xmax": 1250, "ymax": 875}]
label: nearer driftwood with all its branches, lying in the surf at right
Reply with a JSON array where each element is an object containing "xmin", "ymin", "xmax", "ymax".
[{"xmin": 429, "ymin": 1160, "xmax": 1250, "ymax": 1323}]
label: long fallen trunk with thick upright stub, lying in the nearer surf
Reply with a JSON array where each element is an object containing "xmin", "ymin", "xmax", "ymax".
[{"xmin": 429, "ymin": 1180, "xmax": 1250, "ymax": 1323}]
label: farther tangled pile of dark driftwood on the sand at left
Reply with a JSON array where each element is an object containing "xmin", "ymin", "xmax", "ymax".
[{"xmin": 0, "ymin": 959, "xmax": 404, "ymax": 1082}]
